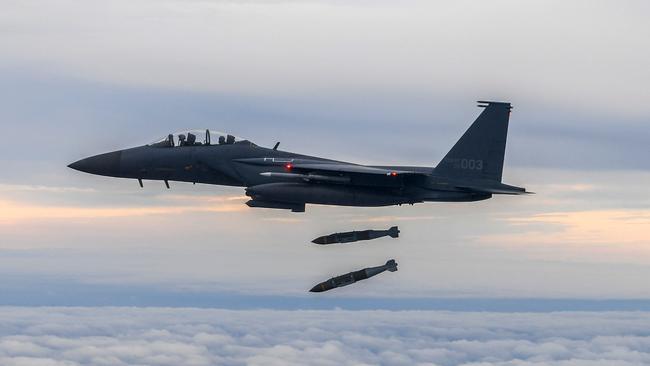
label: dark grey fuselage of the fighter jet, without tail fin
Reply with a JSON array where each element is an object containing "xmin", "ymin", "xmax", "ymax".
[{"xmin": 70, "ymin": 141, "xmax": 490, "ymax": 207}]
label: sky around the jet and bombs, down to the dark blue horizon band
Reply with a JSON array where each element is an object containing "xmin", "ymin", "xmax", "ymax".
[{"xmin": 0, "ymin": 0, "xmax": 650, "ymax": 307}]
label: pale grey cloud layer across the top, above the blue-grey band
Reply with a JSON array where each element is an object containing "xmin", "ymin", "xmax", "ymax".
[{"xmin": 0, "ymin": 0, "xmax": 650, "ymax": 116}]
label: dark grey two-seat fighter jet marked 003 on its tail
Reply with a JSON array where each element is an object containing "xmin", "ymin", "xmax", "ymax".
[{"xmin": 69, "ymin": 101, "xmax": 528, "ymax": 212}]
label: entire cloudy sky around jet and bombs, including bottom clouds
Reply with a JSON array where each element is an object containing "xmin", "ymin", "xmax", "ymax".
[{"xmin": 0, "ymin": 0, "xmax": 650, "ymax": 366}]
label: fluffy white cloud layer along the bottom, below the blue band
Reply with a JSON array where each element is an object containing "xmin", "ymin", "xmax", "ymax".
[{"xmin": 0, "ymin": 307, "xmax": 650, "ymax": 366}]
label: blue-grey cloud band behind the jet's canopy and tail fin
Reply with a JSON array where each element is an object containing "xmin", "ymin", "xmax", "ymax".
[{"xmin": 0, "ymin": 69, "xmax": 650, "ymax": 177}]
